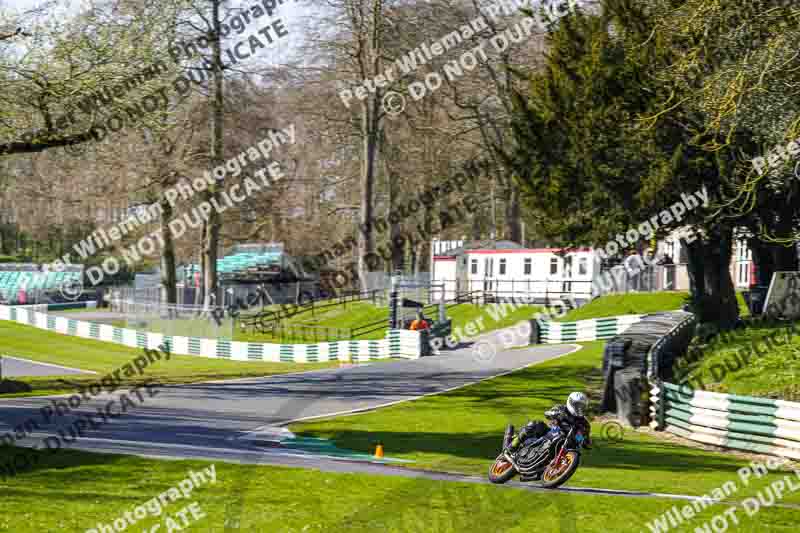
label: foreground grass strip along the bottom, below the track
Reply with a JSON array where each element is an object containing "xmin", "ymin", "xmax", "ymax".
[{"xmin": 0, "ymin": 448, "xmax": 800, "ymax": 533}]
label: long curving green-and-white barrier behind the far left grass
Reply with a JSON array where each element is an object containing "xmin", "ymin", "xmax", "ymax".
[{"xmin": 0, "ymin": 305, "xmax": 422, "ymax": 363}]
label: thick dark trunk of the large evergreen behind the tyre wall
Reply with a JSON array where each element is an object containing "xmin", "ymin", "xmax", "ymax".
[{"xmin": 682, "ymin": 228, "xmax": 739, "ymax": 330}]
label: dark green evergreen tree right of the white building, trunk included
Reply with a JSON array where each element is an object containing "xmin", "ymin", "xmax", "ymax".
[{"xmin": 513, "ymin": 0, "xmax": 738, "ymax": 324}]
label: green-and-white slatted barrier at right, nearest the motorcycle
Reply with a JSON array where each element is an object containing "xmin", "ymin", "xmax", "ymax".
[{"xmin": 650, "ymin": 382, "xmax": 800, "ymax": 460}]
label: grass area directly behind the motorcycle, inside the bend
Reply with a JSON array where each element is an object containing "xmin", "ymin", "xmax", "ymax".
[{"xmin": 291, "ymin": 342, "xmax": 800, "ymax": 501}]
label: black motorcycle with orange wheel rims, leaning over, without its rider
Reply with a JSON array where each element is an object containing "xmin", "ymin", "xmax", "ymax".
[{"xmin": 489, "ymin": 418, "xmax": 586, "ymax": 489}]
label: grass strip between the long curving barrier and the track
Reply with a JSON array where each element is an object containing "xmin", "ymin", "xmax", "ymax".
[{"xmin": 0, "ymin": 321, "xmax": 335, "ymax": 396}]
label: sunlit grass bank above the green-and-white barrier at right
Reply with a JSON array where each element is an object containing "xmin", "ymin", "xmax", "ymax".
[{"xmin": 688, "ymin": 321, "xmax": 800, "ymax": 401}]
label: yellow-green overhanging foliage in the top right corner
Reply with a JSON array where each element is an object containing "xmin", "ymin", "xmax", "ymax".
[{"xmin": 640, "ymin": 0, "xmax": 800, "ymax": 243}]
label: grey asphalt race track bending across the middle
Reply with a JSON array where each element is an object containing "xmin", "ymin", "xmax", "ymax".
[{"xmin": 0, "ymin": 338, "xmax": 577, "ymax": 470}]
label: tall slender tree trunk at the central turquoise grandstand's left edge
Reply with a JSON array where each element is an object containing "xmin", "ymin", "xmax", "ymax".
[{"xmin": 203, "ymin": 0, "xmax": 224, "ymax": 311}]
